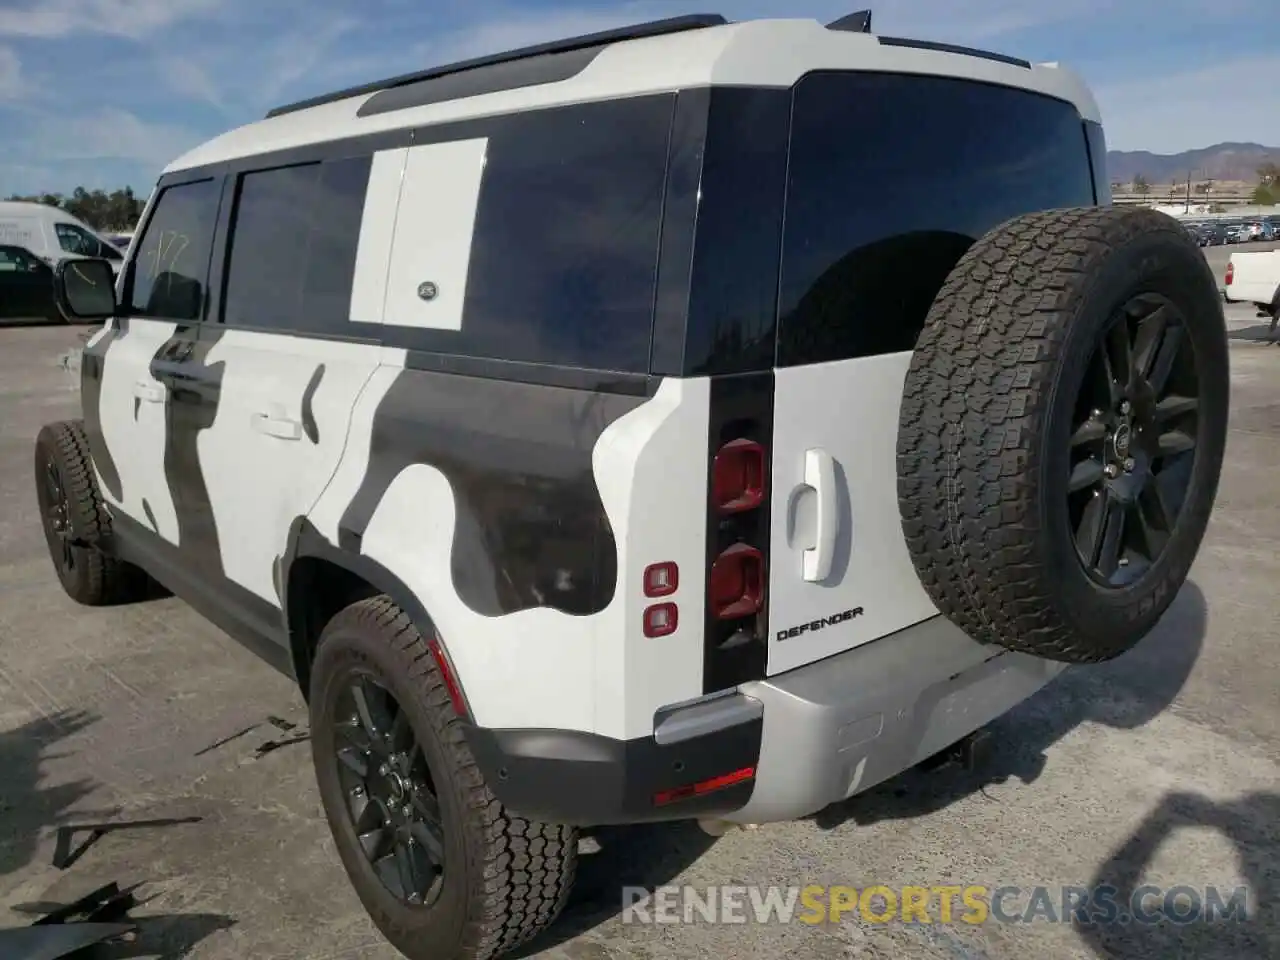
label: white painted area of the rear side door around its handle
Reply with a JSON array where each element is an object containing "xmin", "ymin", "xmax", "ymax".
[{"xmin": 196, "ymin": 330, "xmax": 380, "ymax": 605}]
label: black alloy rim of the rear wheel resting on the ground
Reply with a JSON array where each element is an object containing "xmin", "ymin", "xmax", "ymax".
[{"xmin": 334, "ymin": 671, "xmax": 445, "ymax": 906}]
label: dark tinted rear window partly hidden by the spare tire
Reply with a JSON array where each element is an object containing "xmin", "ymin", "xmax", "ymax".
[{"xmin": 778, "ymin": 73, "xmax": 1094, "ymax": 366}]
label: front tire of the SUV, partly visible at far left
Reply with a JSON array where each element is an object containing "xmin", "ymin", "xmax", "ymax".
[{"xmin": 35, "ymin": 420, "xmax": 163, "ymax": 607}]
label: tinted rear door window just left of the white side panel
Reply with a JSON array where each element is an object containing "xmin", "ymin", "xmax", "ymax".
[{"xmin": 223, "ymin": 156, "xmax": 370, "ymax": 334}]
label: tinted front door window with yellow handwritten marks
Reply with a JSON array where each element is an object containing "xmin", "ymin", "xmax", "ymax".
[{"xmin": 125, "ymin": 180, "xmax": 221, "ymax": 320}]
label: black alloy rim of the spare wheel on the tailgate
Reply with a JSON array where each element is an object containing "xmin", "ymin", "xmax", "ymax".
[{"xmin": 1068, "ymin": 293, "xmax": 1201, "ymax": 588}]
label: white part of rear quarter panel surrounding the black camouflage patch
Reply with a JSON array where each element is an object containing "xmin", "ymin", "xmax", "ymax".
[{"xmin": 350, "ymin": 371, "xmax": 708, "ymax": 737}]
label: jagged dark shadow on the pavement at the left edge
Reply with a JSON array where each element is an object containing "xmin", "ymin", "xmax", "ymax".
[{"xmin": 0, "ymin": 710, "xmax": 97, "ymax": 877}]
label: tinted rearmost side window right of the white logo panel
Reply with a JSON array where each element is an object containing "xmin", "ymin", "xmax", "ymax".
[{"xmin": 385, "ymin": 95, "xmax": 675, "ymax": 372}]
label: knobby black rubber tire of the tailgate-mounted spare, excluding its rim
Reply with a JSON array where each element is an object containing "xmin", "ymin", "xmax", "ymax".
[{"xmin": 897, "ymin": 207, "xmax": 1229, "ymax": 663}]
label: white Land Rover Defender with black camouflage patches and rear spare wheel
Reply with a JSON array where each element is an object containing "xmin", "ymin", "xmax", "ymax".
[{"xmin": 36, "ymin": 9, "xmax": 1228, "ymax": 959}]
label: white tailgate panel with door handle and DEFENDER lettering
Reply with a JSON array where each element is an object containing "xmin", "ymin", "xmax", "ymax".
[{"xmin": 768, "ymin": 353, "xmax": 938, "ymax": 676}]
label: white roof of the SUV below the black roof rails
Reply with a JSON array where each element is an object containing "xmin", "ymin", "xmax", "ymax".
[{"xmin": 165, "ymin": 19, "xmax": 1101, "ymax": 173}]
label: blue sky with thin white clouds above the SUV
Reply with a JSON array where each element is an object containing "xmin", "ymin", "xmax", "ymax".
[{"xmin": 0, "ymin": 0, "xmax": 1280, "ymax": 196}]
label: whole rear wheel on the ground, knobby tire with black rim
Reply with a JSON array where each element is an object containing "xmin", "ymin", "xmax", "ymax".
[{"xmin": 310, "ymin": 596, "xmax": 577, "ymax": 960}]
